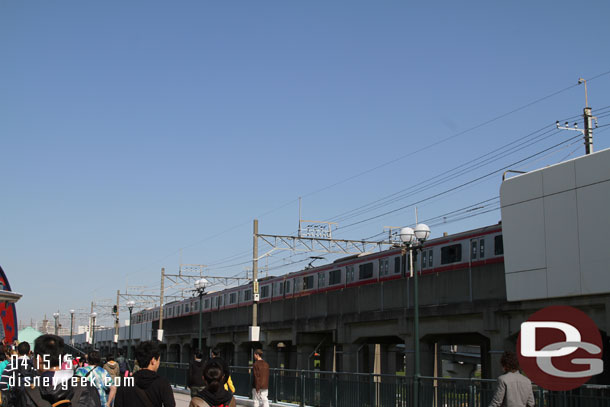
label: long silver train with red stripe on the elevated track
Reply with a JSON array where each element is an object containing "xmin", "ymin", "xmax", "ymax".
[{"xmin": 133, "ymin": 223, "xmax": 504, "ymax": 324}]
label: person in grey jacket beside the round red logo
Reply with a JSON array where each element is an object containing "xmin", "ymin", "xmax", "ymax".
[{"xmin": 489, "ymin": 351, "xmax": 535, "ymax": 407}]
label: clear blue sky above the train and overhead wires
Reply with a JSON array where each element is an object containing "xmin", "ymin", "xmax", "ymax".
[{"xmin": 0, "ymin": 0, "xmax": 610, "ymax": 322}]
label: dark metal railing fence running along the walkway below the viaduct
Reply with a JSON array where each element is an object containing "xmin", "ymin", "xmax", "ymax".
[{"xmin": 159, "ymin": 363, "xmax": 610, "ymax": 407}]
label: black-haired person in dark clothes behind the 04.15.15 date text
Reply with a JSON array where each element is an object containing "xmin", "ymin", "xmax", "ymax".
[{"xmin": 16, "ymin": 334, "xmax": 101, "ymax": 407}]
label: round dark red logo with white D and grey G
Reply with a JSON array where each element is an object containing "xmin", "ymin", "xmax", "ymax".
[{"xmin": 517, "ymin": 306, "xmax": 604, "ymax": 391}]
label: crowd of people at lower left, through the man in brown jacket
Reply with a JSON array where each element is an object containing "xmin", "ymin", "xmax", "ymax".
[{"xmin": 0, "ymin": 334, "xmax": 269, "ymax": 407}]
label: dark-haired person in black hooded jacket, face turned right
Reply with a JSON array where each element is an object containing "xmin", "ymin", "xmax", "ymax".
[{"xmin": 114, "ymin": 341, "xmax": 176, "ymax": 407}]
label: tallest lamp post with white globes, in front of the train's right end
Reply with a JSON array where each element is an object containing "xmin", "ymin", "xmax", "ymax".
[{"xmin": 400, "ymin": 223, "xmax": 430, "ymax": 406}]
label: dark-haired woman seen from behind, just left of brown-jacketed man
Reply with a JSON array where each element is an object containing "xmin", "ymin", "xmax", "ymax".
[{"xmin": 189, "ymin": 359, "xmax": 236, "ymax": 407}]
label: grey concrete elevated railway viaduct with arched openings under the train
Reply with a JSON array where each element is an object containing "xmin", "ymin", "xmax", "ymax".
[{"xmin": 89, "ymin": 263, "xmax": 610, "ymax": 382}]
